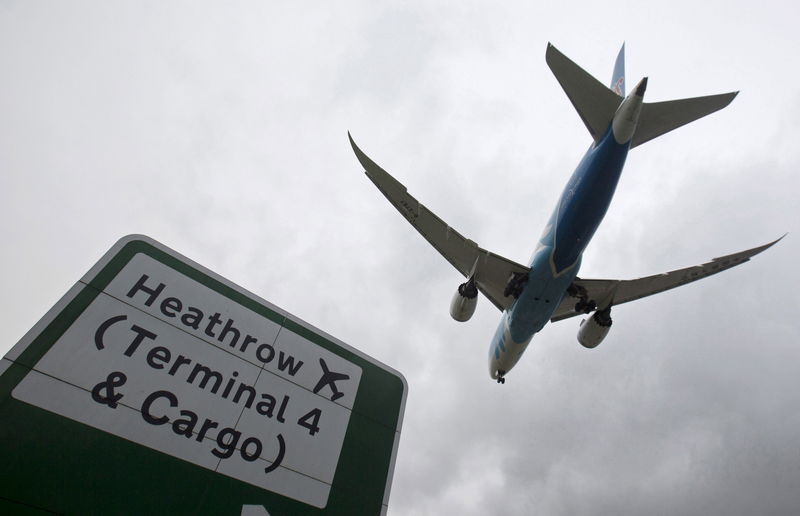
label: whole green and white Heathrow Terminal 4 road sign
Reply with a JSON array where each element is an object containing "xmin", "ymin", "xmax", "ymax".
[{"xmin": 0, "ymin": 236, "xmax": 407, "ymax": 514}]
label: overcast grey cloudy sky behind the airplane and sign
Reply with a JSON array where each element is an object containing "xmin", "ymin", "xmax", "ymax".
[{"xmin": 0, "ymin": 0, "xmax": 800, "ymax": 515}]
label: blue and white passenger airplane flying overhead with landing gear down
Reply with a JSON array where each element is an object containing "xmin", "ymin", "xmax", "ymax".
[{"xmin": 348, "ymin": 43, "xmax": 786, "ymax": 384}]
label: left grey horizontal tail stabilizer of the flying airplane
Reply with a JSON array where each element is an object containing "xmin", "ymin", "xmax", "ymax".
[{"xmin": 545, "ymin": 43, "xmax": 620, "ymax": 142}]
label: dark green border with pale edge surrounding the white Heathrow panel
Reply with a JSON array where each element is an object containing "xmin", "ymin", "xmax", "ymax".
[{"xmin": 0, "ymin": 235, "xmax": 407, "ymax": 516}]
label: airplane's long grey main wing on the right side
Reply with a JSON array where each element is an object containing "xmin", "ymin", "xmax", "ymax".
[{"xmin": 550, "ymin": 235, "xmax": 786, "ymax": 322}]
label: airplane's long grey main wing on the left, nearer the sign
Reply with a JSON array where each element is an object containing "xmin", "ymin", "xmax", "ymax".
[{"xmin": 348, "ymin": 133, "xmax": 530, "ymax": 310}]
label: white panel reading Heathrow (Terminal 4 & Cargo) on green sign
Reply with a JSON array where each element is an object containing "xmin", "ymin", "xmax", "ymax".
[{"xmin": 12, "ymin": 254, "xmax": 362, "ymax": 507}]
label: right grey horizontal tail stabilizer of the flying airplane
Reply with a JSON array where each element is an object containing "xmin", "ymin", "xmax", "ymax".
[{"xmin": 631, "ymin": 91, "xmax": 739, "ymax": 149}]
